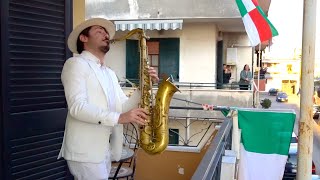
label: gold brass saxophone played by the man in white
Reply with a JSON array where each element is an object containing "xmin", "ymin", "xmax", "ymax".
[{"xmin": 112, "ymin": 29, "xmax": 179, "ymax": 154}]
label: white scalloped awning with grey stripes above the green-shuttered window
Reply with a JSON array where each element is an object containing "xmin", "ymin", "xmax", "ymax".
[{"xmin": 114, "ymin": 20, "xmax": 183, "ymax": 31}]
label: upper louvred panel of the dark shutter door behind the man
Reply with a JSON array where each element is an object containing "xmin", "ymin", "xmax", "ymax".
[{"xmin": 8, "ymin": 0, "xmax": 66, "ymax": 113}]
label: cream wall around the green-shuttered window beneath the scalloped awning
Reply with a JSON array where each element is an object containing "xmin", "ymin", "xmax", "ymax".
[{"xmin": 105, "ymin": 23, "xmax": 217, "ymax": 83}]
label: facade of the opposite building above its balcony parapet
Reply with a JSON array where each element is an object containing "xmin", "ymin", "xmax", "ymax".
[{"xmin": 83, "ymin": 0, "xmax": 270, "ymax": 83}]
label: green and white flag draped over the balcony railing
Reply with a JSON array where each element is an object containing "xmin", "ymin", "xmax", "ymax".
[{"xmin": 238, "ymin": 110, "xmax": 296, "ymax": 180}]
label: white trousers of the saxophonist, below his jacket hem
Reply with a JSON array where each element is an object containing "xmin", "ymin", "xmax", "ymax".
[{"xmin": 67, "ymin": 152, "xmax": 111, "ymax": 180}]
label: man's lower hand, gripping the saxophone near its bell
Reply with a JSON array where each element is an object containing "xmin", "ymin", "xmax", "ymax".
[{"xmin": 118, "ymin": 108, "xmax": 148, "ymax": 125}]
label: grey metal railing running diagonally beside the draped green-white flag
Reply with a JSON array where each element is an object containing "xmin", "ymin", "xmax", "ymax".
[{"xmin": 192, "ymin": 118, "xmax": 232, "ymax": 180}]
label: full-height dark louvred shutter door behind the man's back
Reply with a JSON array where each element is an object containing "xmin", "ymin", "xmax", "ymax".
[{"xmin": 0, "ymin": 0, "xmax": 72, "ymax": 180}]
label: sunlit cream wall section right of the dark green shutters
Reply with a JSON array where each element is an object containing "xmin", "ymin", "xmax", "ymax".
[{"xmin": 179, "ymin": 23, "xmax": 217, "ymax": 83}]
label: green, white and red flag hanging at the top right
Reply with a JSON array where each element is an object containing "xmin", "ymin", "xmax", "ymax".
[{"xmin": 236, "ymin": 0, "xmax": 278, "ymax": 46}]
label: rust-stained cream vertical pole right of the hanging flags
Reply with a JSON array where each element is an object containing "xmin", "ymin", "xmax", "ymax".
[{"xmin": 297, "ymin": 0, "xmax": 317, "ymax": 180}]
